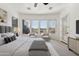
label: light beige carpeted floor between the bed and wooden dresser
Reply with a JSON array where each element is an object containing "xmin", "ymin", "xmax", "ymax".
[{"xmin": 50, "ymin": 40, "xmax": 77, "ymax": 56}]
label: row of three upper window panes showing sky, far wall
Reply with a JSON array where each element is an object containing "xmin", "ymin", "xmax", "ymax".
[{"xmin": 31, "ymin": 20, "xmax": 56, "ymax": 29}]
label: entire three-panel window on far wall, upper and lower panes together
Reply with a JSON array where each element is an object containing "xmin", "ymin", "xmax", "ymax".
[{"xmin": 31, "ymin": 20, "xmax": 57, "ymax": 33}]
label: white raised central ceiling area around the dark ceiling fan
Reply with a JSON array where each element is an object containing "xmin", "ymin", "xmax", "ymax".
[{"xmin": 10, "ymin": 3, "xmax": 66, "ymax": 14}]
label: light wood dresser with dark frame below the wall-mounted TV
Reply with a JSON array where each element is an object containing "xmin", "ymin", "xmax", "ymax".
[{"xmin": 68, "ymin": 37, "xmax": 79, "ymax": 55}]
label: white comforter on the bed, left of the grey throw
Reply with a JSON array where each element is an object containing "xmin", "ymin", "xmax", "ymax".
[{"xmin": 0, "ymin": 36, "xmax": 42, "ymax": 56}]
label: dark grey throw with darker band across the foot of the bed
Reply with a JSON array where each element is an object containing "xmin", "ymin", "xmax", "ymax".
[{"xmin": 29, "ymin": 41, "xmax": 50, "ymax": 56}]
